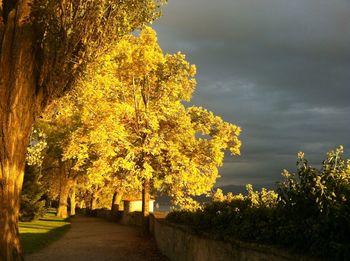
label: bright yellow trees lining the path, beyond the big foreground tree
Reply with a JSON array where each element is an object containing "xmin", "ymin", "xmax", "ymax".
[{"xmin": 25, "ymin": 27, "xmax": 240, "ymax": 220}]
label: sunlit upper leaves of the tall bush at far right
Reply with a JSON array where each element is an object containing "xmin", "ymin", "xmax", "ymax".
[{"xmin": 279, "ymin": 146, "xmax": 350, "ymax": 212}]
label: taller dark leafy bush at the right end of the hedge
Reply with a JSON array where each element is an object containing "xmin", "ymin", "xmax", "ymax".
[{"xmin": 277, "ymin": 147, "xmax": 350, "ymax": 259}]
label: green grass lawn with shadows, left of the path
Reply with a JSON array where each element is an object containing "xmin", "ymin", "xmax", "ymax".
[{"xmin": 19, "ymin": 210, "xmax": 70, "ymax": 254}]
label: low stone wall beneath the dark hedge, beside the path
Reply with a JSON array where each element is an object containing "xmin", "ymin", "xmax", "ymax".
[{"xmin": 150, "ymin": 213, "xmax": 315, "ymax": 261}]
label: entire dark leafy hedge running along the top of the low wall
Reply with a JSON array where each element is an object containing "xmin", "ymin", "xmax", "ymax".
[{"xmin": 167, "ymin": 147, "xmax": 350, "ymax": 260}]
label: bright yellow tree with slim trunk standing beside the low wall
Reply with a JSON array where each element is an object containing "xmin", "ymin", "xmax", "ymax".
[{"xmin": 57, "ymin": 28, "xmax": 240, "ymax": 216}]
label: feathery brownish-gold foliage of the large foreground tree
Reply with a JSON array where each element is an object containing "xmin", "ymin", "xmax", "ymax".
[{"xmin": 30, "ymin": 0, "xmax": 166, "ymax": 96}]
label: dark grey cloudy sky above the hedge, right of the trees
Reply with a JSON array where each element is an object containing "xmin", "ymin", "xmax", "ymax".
[{"xmin": 154, "ymin": 0, "xmax": 350, "ymax": 185}]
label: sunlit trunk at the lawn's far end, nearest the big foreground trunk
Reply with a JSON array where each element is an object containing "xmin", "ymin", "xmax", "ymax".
[{"xmin": 57, "ymin": 162, "xmax": 71, "ymax": 218}]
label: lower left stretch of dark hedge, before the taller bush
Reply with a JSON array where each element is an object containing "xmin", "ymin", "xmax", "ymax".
[{"xmin": 167, "ymin": 185, "xmax": 277, "ymax": 241}]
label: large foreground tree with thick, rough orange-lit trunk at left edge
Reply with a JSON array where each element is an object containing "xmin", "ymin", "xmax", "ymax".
[{"xmin": 0, "ymin": 0, "xmax": 162, "ymax": 260}]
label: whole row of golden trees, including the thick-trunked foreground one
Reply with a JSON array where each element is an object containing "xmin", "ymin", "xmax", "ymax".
[{"xmin": 0, "ymin": 0, "xmax": 240, "ymax": 260}]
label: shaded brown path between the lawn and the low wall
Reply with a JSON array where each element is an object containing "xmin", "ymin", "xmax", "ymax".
[{"xmin": 26, "ymin": 215, "xmax": 168, "ymax": 261}]
